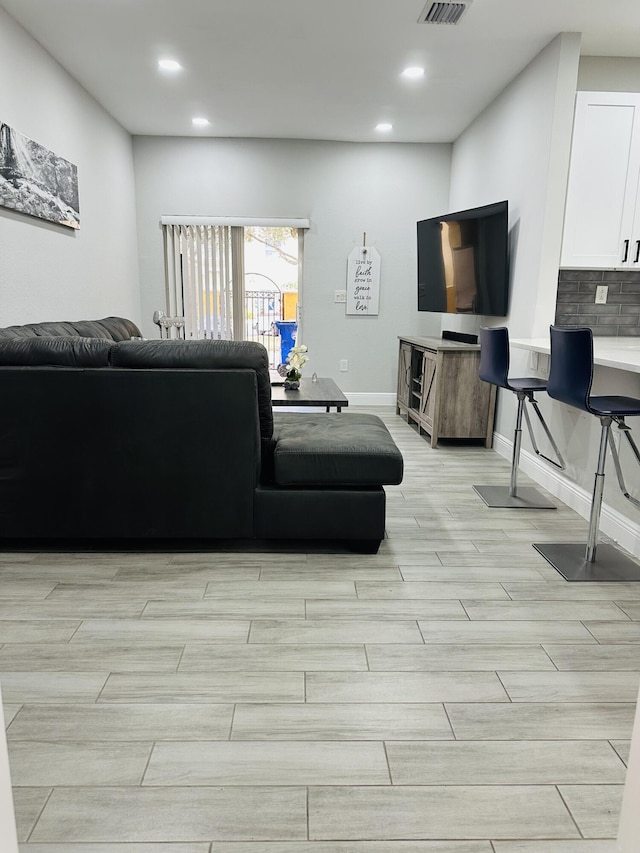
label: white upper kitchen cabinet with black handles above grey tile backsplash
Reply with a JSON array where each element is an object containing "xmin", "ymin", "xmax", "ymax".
[{"xmin": 561, "ymin": 92, "xmax": 640, "ymax": 268}]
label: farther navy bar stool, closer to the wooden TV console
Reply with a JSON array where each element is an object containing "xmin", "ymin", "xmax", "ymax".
[{"xmin": 473, "ymin": 326, "xmax": 564, "ymax": 509}]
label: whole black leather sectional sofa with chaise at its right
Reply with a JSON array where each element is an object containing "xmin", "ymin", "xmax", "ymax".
[{"xmin": 0, "ymin": 317, "xmax": 403, "ymax": 552}]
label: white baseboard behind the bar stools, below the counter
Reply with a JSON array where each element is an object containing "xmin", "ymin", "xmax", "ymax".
[{"xmin": 493, "ymin": 433, "xmax": 640, "ymax": 557}]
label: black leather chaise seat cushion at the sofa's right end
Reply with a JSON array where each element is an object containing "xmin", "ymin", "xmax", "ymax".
[{"xmin": 273, "ymin": 412, "xmax": 403, "ymax": 487}]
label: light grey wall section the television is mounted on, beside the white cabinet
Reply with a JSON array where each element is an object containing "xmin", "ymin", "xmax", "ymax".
[{"xmin": 450, "ymin": 33, "xmax": 580, "ymax": 446}]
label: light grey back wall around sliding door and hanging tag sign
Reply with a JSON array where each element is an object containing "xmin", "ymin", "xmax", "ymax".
[{"xmin": 134, "ymin": 137, "xmax": 451, "ymax": 393}]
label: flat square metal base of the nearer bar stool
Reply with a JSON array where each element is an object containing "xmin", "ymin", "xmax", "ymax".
[{"xmin": 533, "ymin": 542, "xmax": 640, "ymax": 582}]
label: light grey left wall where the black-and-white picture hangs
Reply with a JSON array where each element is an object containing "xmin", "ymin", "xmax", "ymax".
[{"xmin": 0, "ymin": 8, "xmax": 140, "ymax": 326}]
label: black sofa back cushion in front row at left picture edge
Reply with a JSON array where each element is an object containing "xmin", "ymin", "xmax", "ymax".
[{"xmin": 0, "ymin": 335, "xmax": 113, "ymax": 367}]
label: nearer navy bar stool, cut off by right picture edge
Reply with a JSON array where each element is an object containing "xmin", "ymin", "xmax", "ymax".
[{"xmin": 533, "ymin": 326, "xmax": 640, "ymax": 581}]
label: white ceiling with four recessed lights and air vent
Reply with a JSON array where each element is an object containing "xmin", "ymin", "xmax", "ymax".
[{"xmin": 0, "ymin": 0, "xmax": 640, "ymax": 142}]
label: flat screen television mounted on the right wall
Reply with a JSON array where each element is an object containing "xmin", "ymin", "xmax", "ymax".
[{"xmin": 418, "ymin": 201, "xmax": 509, "ymax": 317}]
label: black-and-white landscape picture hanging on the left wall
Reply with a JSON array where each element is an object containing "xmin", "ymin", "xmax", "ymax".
[{"xmin": 0, "ymin": 122, "xmax": 80, "ymax": 228}]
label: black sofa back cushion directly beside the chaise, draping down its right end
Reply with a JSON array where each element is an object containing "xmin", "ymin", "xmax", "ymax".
[{"xmin": 111, "ymin": 340, "xmax": 273, "ymax": 439}]
